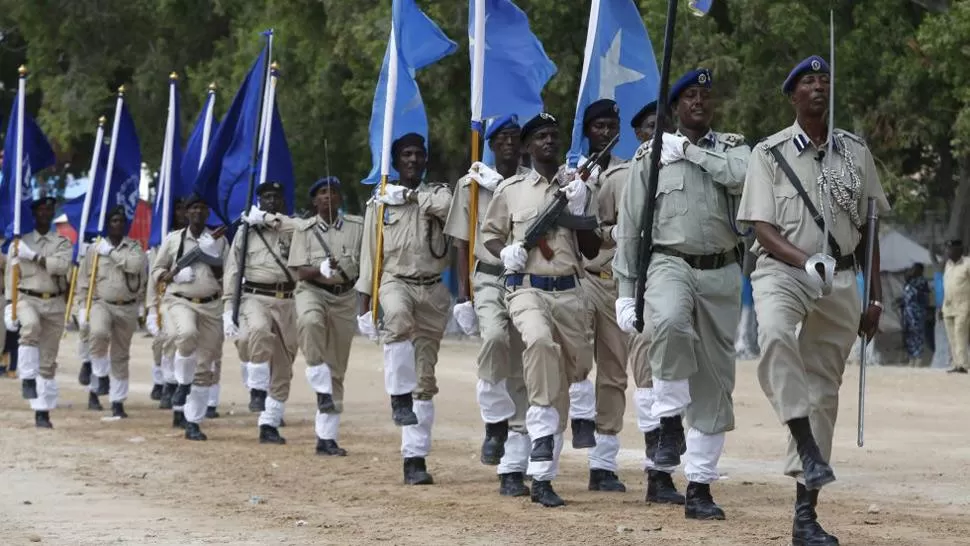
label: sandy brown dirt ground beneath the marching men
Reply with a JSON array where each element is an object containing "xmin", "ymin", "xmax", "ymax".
[{"xmin": 0, "ymin": 334, "xmax": 970, "ymax": 545}]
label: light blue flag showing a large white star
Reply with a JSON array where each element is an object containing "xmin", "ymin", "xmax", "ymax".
[{"xmin": 566, "ymin": 0, "xmax": 660, "ymax": 167}]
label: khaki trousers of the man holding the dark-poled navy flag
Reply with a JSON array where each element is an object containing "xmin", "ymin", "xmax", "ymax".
[{"xmin": 236, "ymin": 294, "xmax": 297, "ymax": 402}]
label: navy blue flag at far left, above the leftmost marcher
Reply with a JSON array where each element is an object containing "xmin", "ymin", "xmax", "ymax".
[{"xmin": 0, "ymin": 96, "xmax": 54, "ymax": 240}]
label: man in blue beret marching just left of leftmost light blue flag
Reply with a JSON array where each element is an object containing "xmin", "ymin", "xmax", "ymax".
[{"xmin": 287, "ymin": 176, "xmax": 364, "ymax": 457}]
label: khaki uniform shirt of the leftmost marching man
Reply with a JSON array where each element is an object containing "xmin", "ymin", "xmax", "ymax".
[{"xmin": 4, "ymin": 227, "xmax": 73, "ymax": 299}]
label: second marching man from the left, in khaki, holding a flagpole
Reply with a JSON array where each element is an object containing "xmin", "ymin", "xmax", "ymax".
[{"xmin": 77, "ymin": 205, "xmax": 146, "ymax": 418}]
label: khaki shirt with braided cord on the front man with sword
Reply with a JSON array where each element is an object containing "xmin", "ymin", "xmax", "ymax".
[{"xmin": 738, "ymin": 121, "xmax": 889, "ymax": 256}]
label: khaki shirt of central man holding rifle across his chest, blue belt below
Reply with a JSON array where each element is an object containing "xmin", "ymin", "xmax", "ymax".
[{"xmin": 482, "ymin": 170, "xmax": 584, "ymax": 277}]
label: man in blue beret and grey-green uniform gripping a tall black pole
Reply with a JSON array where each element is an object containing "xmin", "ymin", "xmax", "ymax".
[{"xmin": 613, "ymin": 69, "xmax": 750, "ymax": 519}]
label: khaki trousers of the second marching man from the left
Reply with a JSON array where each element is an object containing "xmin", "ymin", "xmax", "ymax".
[{"xmin": 88, "ymin": 300, "xmax": 138, "ymax": 380}]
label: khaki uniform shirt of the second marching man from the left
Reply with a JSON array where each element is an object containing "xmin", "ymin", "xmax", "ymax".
[{"xmin": 75, "ymin": 237, "xmax": 147, "ymax": 305}]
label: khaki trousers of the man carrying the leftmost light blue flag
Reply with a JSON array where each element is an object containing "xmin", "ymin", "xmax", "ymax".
[{"xmin": 380, "ymin": 275, "xmax": 451, "ymax": 400}]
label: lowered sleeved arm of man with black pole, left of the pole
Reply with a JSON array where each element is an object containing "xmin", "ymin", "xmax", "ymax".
[{"xmin": 613, "ymin": 155, "xmax": 652, "ymax": 298}]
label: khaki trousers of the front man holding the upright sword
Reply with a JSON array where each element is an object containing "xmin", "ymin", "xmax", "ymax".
[{"xmin": 751, "ymin": 257, "xmax": 861, "ymax": 476}]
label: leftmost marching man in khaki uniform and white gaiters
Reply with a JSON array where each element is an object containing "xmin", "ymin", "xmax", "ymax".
[{"xmin": 4, "ymin": 197, "xmax": 71, "ymax": 428}]
